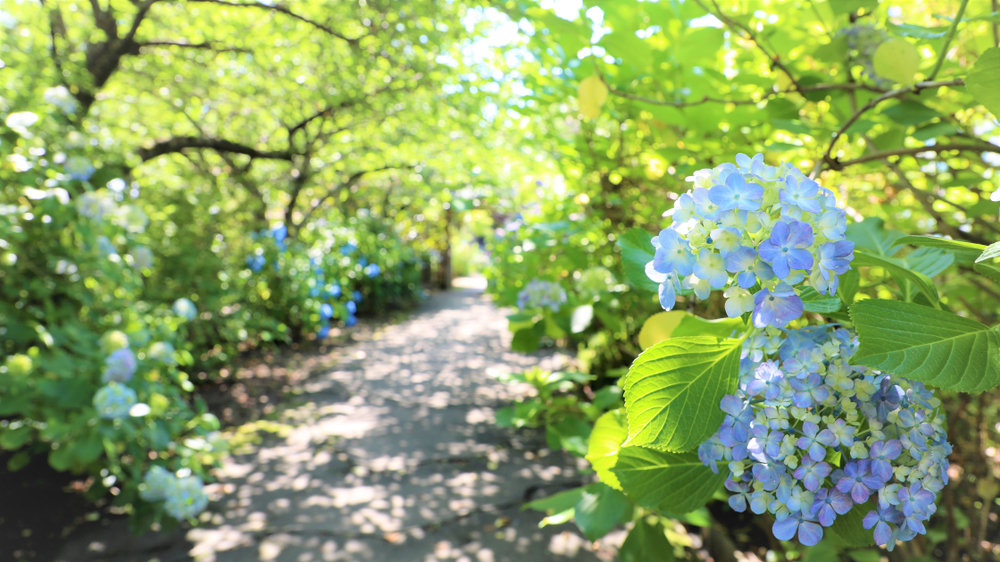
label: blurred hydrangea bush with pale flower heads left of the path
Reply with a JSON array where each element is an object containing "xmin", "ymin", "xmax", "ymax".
[{"xmin": 0, "ymin": 104, "xmax": 225, "ymax": 529}]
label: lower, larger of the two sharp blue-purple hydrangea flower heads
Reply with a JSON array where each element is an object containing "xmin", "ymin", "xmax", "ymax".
[{"xmin": 698, "ymin": 326, "xmax": 951, "ymax": 550}]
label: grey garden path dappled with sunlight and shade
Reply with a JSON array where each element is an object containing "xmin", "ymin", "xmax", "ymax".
[{"xmin": 58, "ymin": 280, "xmax": 613, "ymax": 562}]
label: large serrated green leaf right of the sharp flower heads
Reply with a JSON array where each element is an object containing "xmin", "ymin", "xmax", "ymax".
[{"xmin": 851, "ymin": 299, "xmax": 1000, "ymax": 392}]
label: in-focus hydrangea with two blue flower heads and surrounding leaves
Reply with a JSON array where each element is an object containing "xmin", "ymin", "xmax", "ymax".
[{"xmin": 568, "ymin": 154, "xmax": 1000, "ymax": 550}]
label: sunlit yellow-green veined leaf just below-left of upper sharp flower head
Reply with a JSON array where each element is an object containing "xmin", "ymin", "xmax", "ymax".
[{"xmin": 621, "ymin": 336, "xmax": 743, "ymax": 452}]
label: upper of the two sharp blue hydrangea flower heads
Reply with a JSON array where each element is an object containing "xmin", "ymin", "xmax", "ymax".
[{"xmin": 646, "ymin": 154, "xmax": 854, "ymax": 328}]
